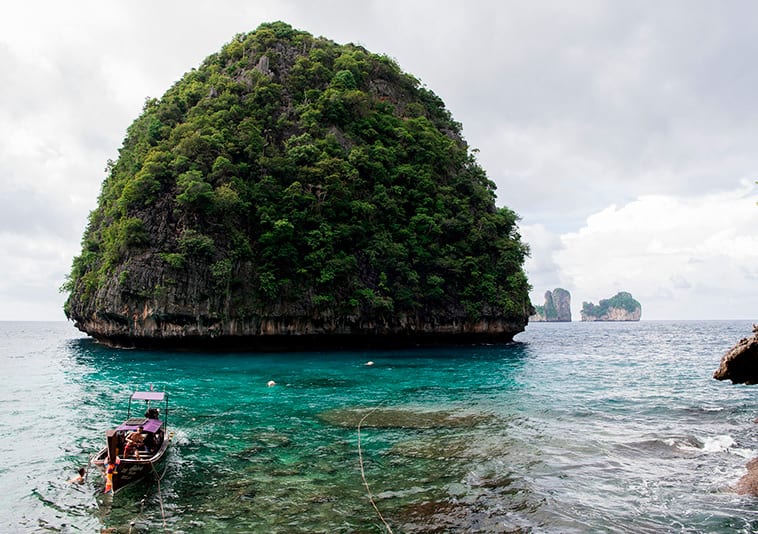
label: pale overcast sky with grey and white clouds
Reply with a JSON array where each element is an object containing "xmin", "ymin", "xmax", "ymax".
[{"xmin": 0, "ymin": 0, "xmax": 758, "ymax": 320}]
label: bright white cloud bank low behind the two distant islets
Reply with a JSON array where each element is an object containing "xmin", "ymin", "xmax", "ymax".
[{"xmin": 553, "ymin": 183, "xmax": 758, "ymax": 319}]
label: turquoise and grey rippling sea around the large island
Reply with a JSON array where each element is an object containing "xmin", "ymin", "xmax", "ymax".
[{"xmin": 0, "ymin": 320, "xmax": 758, "ymax": 533}]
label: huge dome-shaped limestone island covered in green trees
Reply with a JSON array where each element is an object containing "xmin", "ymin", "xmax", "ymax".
[{"xmin": 64, "ymin": 22, "xmax": 532, "ymax": 350}]
